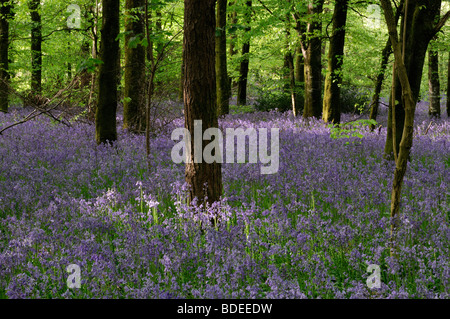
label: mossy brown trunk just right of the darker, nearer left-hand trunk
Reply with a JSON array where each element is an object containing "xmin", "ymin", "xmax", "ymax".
[{"xmin": 123, "ymin": 0, "xmax": 146, "ymax": 132}]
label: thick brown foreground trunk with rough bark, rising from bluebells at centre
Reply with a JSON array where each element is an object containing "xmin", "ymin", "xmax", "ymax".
[{"xmin": 183, "ymin": 0, "xmax": 222, "ymax": 203}]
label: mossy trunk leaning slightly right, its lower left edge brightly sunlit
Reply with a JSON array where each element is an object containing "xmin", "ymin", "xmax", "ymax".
[{"xmin": 322, "ymin": 0, "xmax": 348, "ymax": 124}]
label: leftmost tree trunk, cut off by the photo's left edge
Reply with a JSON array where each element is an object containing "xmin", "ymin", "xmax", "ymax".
[{"xmin": 0, "ymin": 0, "xmax": 11, "ymax": 112}]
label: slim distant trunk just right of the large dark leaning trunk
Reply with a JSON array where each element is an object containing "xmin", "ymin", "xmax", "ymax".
[{"xmin": 428, "ymin": 48, "xmax": 441, "ymax": 117}]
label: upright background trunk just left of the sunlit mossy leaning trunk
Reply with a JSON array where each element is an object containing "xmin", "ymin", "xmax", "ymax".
[{"xmin": 302, "ymin": 0, "xmax": 324, "ymax": 118}]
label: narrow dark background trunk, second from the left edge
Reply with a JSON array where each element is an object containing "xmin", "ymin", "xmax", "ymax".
[{"xmin": 28, "ymin": 0, "xmax": 42, "ymax": 95}]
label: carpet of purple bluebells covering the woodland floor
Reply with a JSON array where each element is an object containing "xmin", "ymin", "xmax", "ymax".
[{"xmin": 0, "ymin": 102, "xmax": 450, "ymax": 299}]
